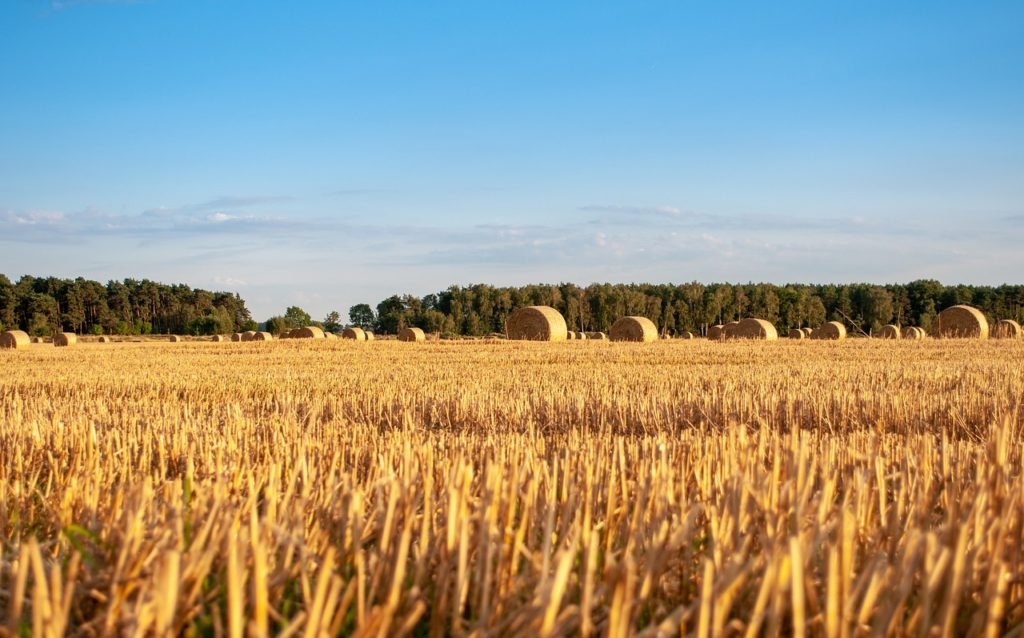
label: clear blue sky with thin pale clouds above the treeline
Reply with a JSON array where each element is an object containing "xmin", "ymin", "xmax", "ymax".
[{"xmin": 0, "ymin": 0, "xmax": 1024, "ymax": 318}]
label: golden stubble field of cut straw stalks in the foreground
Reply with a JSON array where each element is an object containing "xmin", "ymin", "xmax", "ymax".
[{"xmin": 0, "ymin": 339, "xmax": 1024, "ymax": 637}]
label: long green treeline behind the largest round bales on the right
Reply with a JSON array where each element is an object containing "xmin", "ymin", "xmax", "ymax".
[{"xmin": 349, "ymin": 280, "xmax": 1024, "ymax": 335}]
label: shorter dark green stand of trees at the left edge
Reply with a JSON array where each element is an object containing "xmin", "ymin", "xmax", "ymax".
[{"xmin": 0, "ymin": 274, "xmax": 256, "ymax": 336}]
